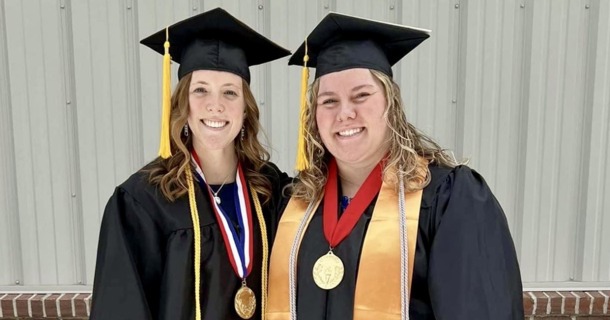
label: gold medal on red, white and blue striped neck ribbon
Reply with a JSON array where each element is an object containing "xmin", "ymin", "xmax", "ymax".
[{"xmin": 193, "ymin": 153, "xmax": 256, "ymax": 319}]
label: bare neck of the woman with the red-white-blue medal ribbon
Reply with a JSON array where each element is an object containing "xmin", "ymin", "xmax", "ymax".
[{"xmin": 195, "ymin": 148, "xmax": 237, "ymax": 184}]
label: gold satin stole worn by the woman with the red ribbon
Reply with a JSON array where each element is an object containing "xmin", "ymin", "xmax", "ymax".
[{"xmin": 265, "ymin": 183, "xmax": 423, "ymax": 320}]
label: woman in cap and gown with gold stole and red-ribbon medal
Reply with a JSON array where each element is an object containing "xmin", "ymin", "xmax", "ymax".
[{"xmin": 267, "ymin": 13, "xmax": 523, "ymax": 320}]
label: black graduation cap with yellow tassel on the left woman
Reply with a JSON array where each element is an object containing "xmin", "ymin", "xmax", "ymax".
[{"xmin": 140, "ymin": 8, "xmax": 290, "ymax": 158}]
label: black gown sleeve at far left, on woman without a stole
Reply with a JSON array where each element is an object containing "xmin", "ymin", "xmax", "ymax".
[{"xmin": 91, "ymin": 188, "xmax": 163, "ymax": 320}]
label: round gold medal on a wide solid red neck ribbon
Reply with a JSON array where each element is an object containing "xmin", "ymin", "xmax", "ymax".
[{"xmin": 312, "ymin": 158, "xmax": 382, "ymax": 290}]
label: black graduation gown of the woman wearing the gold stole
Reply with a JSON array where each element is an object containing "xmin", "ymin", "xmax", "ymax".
[{"xmin": 297, "ymin": 165, "xmax": 523, "ymax": 320}]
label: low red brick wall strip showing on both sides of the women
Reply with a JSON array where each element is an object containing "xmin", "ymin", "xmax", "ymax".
[{"xmin": 0, "ymin": 290, "xmax": 610, "ymax": 320}]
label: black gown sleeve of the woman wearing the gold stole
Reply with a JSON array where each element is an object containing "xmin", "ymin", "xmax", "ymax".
[{"xmin": 428, "ymin": 167, "xmax": 523, "ymax": 320}]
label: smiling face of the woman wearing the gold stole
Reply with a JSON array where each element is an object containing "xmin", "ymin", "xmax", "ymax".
[{"xmin": 316, "ymin": 69, "xmax": 389, "ymax": 168}]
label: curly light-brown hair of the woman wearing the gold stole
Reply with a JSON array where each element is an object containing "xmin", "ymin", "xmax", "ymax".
[{"xmin": 292, "ymin": 70, "xmax": 458, "ymax": 201}]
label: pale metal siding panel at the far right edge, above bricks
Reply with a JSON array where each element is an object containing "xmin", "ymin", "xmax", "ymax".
[{"xmin": 575, "ymin": 1, "xmax": 610, "ymax": 281}]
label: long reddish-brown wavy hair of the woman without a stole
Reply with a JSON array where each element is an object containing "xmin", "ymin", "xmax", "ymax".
[{"xmin": 143, "ymin": 73, "xmax": 271, "ymax": 203}]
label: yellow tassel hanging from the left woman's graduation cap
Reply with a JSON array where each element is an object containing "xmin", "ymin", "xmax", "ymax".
[{"xmin": 159, "ymin": 28, "xmax": 172, "ymax": 159}]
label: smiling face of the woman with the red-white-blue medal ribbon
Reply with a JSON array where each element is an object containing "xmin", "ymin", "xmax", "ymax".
[{"xmin": 188, "ymin": 70, "xmax": 245, "ymax": 155}]
